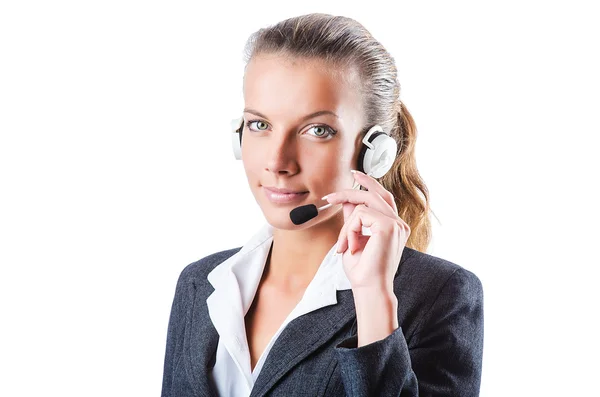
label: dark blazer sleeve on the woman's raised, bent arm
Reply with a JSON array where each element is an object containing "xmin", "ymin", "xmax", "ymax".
[{"xmin": 335, "ymin": 268, "xmax": 483, "ymax": 397}]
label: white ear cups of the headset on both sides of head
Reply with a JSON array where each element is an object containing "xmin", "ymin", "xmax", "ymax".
[{"xmin": 231, "ymin": 117, "xmax": 398, "ymax": 178}]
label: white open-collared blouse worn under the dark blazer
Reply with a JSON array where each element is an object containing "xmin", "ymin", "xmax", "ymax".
[{"xmin": 206, "ymin": 223, "xmax": 351, "ymax": 397}]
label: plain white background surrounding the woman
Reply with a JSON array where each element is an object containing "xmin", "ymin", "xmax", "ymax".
[{"xmin": 0, "ymin": 0, "xmax": 600, "ymax": 396}]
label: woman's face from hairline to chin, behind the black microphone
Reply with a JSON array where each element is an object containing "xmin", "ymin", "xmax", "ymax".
[{"xmin": 242, "ymin": 55, "xmax": 364, "ymax": 229}]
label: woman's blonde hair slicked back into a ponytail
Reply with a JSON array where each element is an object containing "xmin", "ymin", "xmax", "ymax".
[{"xmin": 244, "ymin": 13, "xmax": 431, "ymax": 252}]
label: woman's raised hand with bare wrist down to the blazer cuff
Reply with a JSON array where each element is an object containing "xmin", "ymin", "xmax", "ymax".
[{"xmin": 325, "ymin": 171, "xmax": 410, "ymax": 347}]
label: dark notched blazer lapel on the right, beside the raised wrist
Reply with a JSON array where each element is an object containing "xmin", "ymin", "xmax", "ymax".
[{"xmin": 250, "ymin": 289, "xmax": 356, "ymax": 397}]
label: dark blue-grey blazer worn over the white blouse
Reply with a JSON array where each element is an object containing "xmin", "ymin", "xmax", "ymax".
[{"xmin": 162, "ymin": 247, "xmax": 483, "ymax": 397}]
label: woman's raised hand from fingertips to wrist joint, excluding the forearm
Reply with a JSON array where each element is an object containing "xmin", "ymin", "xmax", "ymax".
[{"xmin": 325, "ymin": 171, "xmax": 410, "ymax": 294}]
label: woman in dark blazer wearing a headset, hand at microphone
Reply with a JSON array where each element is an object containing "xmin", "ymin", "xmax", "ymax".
[{"xmin": 162, "ymin": 14, "xmax": 483, "ymax": 397}]
